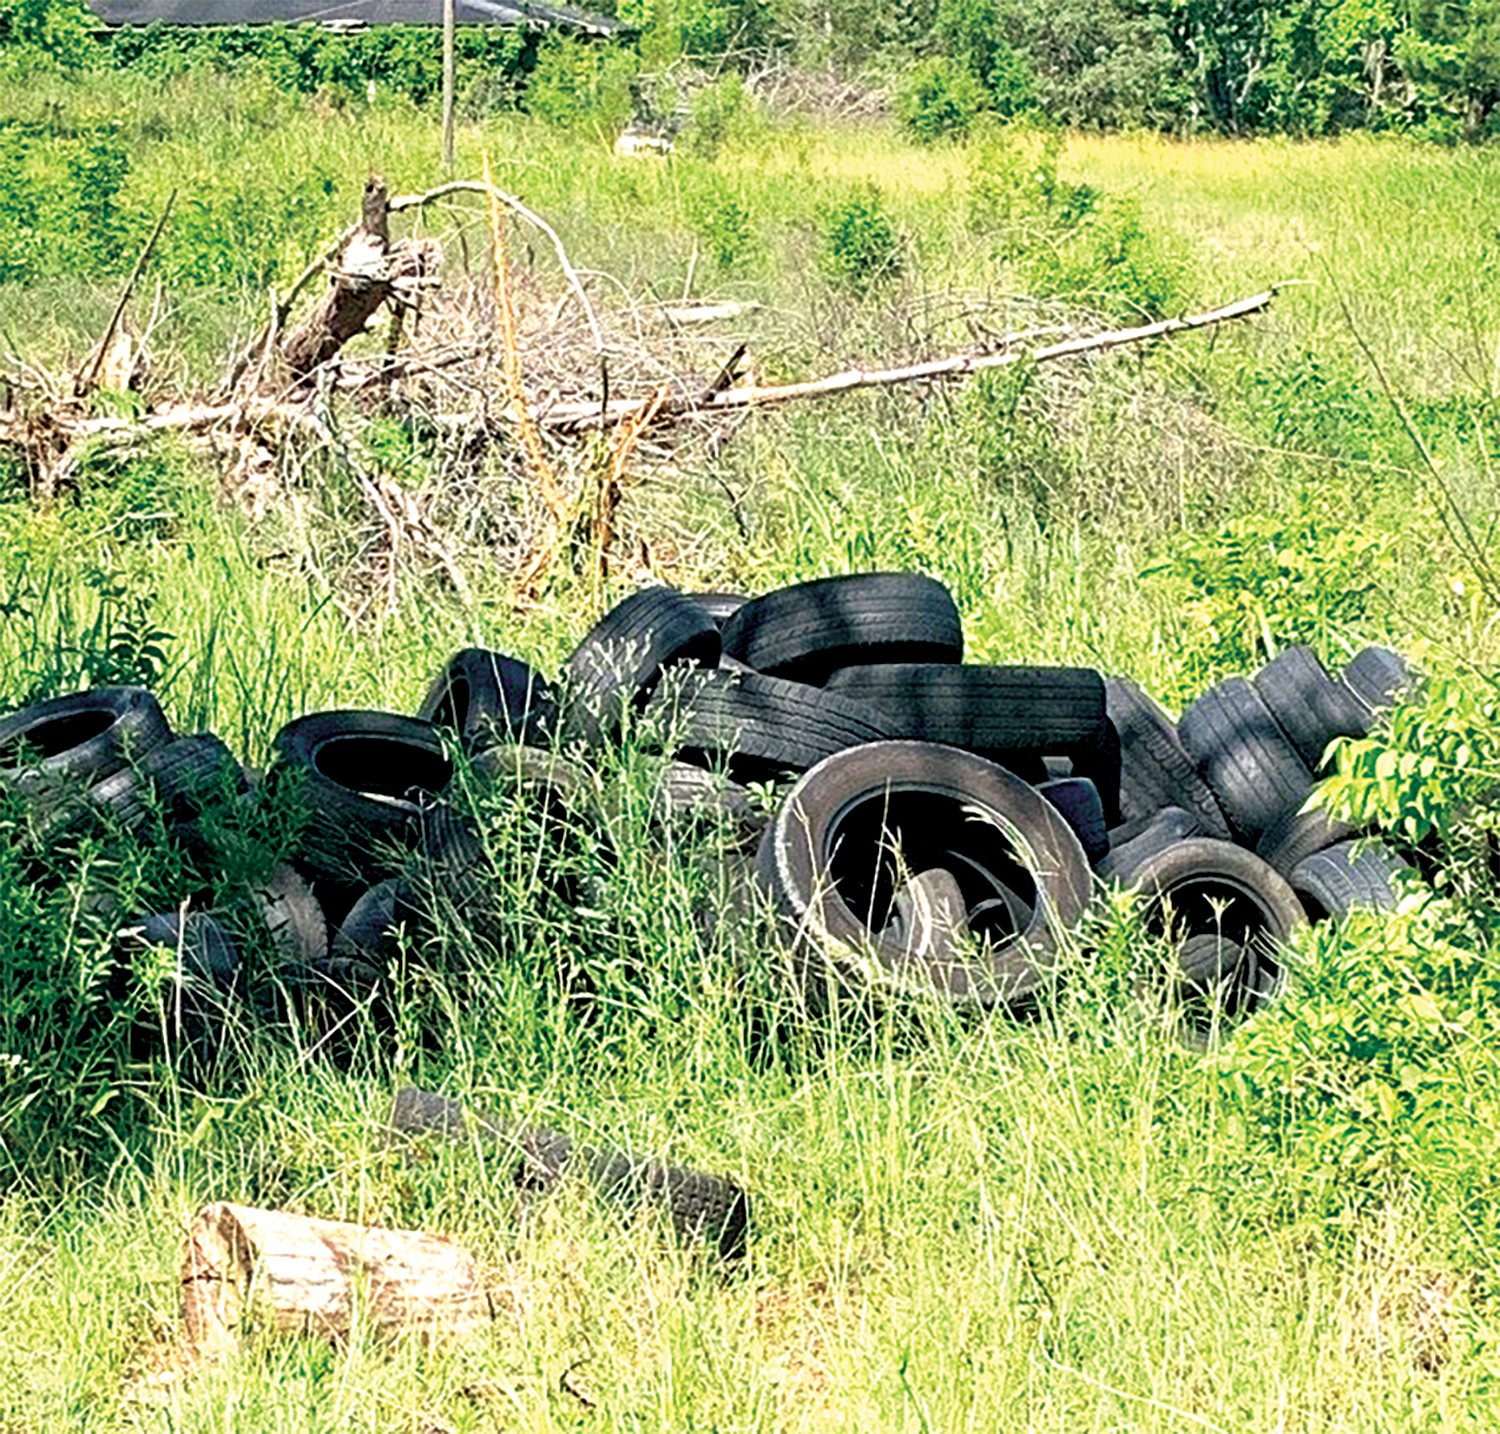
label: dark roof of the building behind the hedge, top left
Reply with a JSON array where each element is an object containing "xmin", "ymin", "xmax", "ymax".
[{"xmin": 89, "ymin": 0, "xmax": 617, "ymax": 35}]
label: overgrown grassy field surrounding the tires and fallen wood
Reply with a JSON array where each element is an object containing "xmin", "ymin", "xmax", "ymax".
[{"xmin": 0, "ymin": 67, "xmax": 1500, "ymax": 1434}]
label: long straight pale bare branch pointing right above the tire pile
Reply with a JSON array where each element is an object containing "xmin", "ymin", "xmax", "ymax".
[{"xmin": 534, "ymin": 288, "xmax": 1277, "ymax": 434}]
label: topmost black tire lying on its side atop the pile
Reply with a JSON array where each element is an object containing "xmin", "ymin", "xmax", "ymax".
[{"xmin": 723, "ymin": 573, "xmax": 963, "ymax": 687}]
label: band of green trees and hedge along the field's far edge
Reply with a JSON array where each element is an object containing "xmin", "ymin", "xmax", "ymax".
[{"xmin": 0, "ymin": 0, "xmax": 1500, "ymax": 141}]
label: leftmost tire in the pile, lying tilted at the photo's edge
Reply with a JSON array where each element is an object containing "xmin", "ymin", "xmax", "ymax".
[{"xmin": 0, "ymin": 687, "xmax": 173, "ymax": 803}]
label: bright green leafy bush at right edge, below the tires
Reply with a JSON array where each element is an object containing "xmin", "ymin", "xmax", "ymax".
[{"xmin": 1214, "ymin": 897, "xmax": 1500, "ymax": 1251}]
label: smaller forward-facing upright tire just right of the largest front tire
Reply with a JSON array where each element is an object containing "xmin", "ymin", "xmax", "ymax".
[{"xmin": 1115, "ymin": 837, "xmax": 1307, "ymax": 1008}]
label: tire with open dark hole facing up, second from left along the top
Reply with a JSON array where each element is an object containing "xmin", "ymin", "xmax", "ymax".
[{"xmin": 266, "ymin": 711, "xmax": 453, "ymax": 885}]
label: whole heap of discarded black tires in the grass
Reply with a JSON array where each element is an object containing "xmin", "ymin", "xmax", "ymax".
[{"xmin": 0, "ymin": 573, "xmax": 1410, "ymax": 1056}]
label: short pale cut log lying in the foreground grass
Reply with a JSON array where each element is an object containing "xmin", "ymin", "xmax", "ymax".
[{"xmin": 182, "ymin": 1203, "xmax": 491, "ymax": 1358}]
